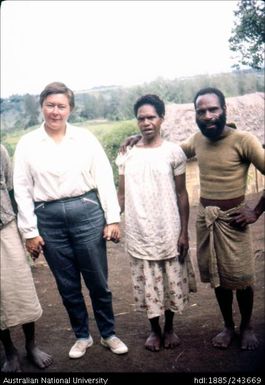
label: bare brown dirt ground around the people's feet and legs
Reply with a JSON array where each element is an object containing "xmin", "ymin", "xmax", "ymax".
[{"xmin": 0, "ymin": 194, "xmax": 265, "ymax": 385}]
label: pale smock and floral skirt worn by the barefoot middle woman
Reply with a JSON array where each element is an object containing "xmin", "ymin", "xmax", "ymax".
[{"xmin": 116, "ymin": 140, "xmax": 194, "ymax": 318}]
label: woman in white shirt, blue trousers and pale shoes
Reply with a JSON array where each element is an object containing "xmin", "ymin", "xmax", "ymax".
[{"xmin": 14, "ymin": 82, "xmax": 128, "ymax": 358}]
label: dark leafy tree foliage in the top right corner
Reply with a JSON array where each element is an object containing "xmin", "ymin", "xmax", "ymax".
[{"xmin": 229, "ymin": 0, "xmax": 265, "ymax": 69}]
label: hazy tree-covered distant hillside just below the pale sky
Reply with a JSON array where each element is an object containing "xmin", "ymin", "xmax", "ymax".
[{"xmin": 1, "ymin": 70, "xmax": 264, "ymax": 132}]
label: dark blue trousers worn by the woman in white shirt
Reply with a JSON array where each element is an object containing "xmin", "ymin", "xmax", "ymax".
[{"xmin": 35, "ymin": 191, "xmax": 115, "ymax": 338}]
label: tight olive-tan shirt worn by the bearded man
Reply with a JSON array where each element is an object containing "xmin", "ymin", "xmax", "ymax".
[{"xmin": 181, "ymin": 126, "xmax": 265, "ymax": 199}]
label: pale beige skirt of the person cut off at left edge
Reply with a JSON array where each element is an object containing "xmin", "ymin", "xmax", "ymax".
[{"xmin": 0, "ymin": 220, "xmax": 42, "ymax": 330}]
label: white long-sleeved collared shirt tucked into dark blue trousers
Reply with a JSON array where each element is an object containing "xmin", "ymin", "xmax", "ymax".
[{"xmin": 14, "ymin": 123, "xmax": 120, "ymax": 239}]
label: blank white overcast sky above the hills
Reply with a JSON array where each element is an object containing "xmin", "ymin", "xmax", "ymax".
[{"xmin": 1, "ymin": 0, "xmax": 237, "ymax": 98}]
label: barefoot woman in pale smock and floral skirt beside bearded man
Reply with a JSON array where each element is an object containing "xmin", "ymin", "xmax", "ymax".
[{"xmin": 116, "ymin": 95, "xmax": 194, "ymax": 351}]
